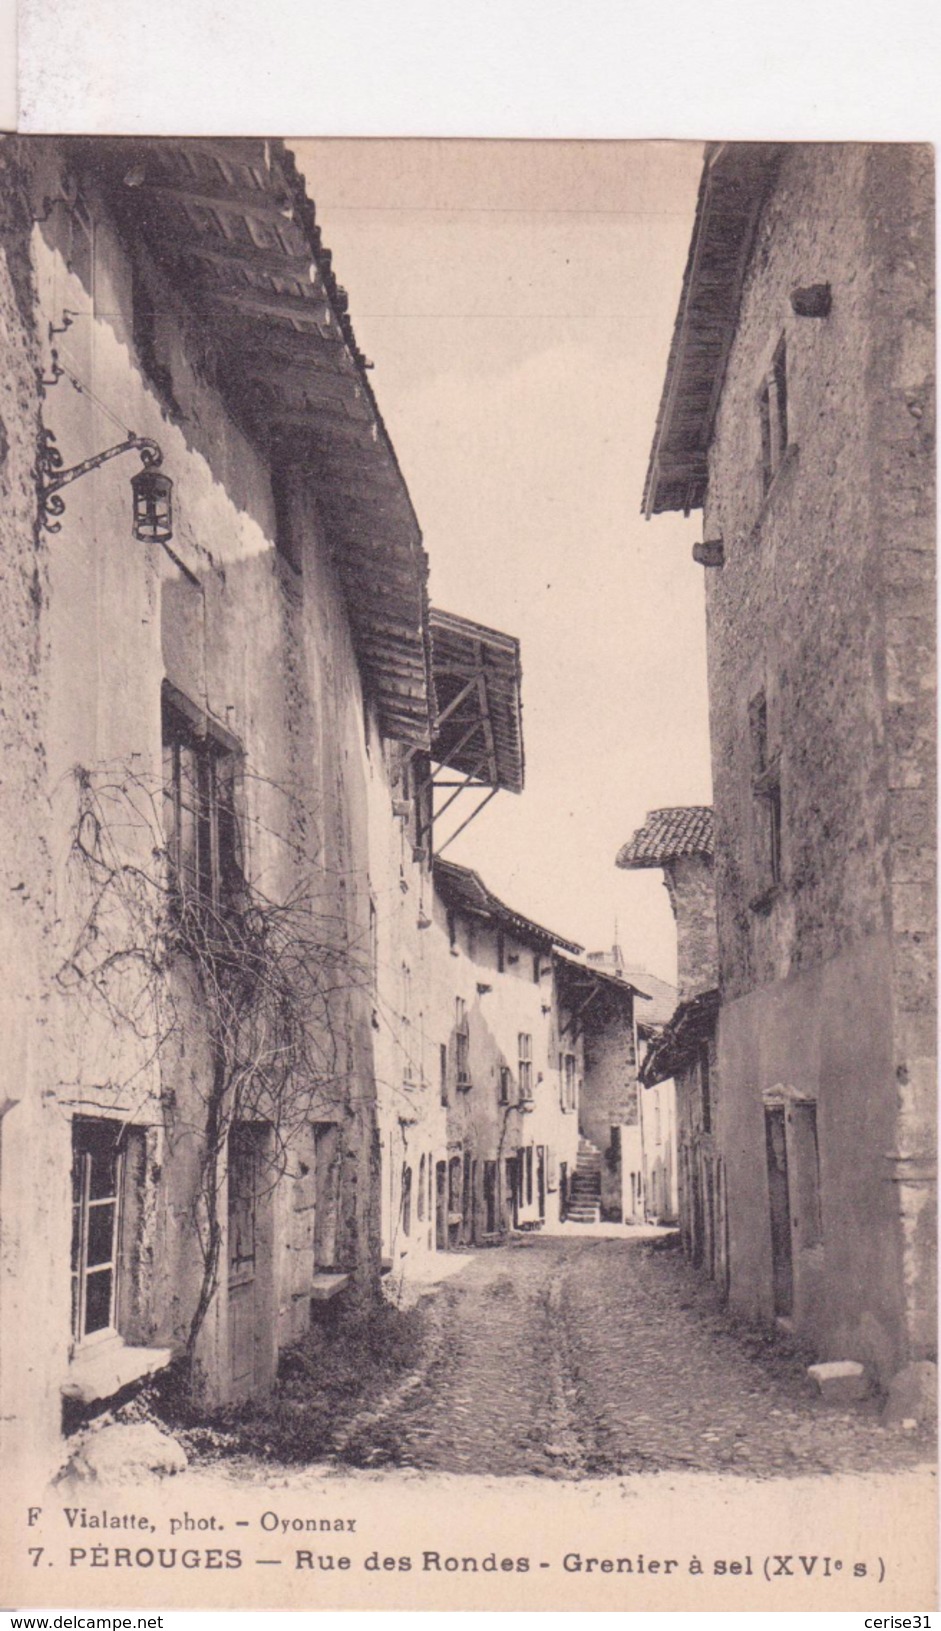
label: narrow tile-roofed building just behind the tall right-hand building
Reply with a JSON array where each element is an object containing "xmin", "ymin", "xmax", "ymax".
[{"xmin": 616, "ymin": 806, "xmax": 714, "ymax": 1282}]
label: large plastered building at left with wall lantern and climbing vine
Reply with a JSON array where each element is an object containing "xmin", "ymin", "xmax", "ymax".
[{"xmin": 0, "ymin": 139, "xmax": 434, "ymax": 1453}]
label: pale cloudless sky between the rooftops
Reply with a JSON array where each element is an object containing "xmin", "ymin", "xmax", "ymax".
[{"xmin": 295, "ymin": 139, "xmax": 711, "ymax": 980}]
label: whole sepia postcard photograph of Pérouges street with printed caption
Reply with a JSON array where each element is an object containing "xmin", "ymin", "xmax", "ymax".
[{"xmin": 0, "ymin": 123, "xmax": 938, "ymax": 1604}]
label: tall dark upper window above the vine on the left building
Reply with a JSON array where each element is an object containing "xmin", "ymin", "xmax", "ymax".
[{"xmin": 163, "ymin": 687, "xmax": 241, "ymax": 910}]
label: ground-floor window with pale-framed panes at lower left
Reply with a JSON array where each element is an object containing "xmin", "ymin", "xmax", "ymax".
[{"xmin": 72, "ymin": 1117, "xmax": 144, "ymax": 1344}]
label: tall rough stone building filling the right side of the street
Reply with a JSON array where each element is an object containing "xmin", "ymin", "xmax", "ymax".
[{"xmin": 644, "ymin": 144, "xmax": 936, "ymax": 1380}]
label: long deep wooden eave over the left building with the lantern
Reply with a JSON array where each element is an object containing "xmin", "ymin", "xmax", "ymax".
[{"xmin": 75, "ymin": 137, "xmax": 434, "ymax": 750}]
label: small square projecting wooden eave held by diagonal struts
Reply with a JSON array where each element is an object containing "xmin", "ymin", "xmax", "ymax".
[{"xmin": 431, "ymin": 608, "xmax": 525, "ymax": 793}]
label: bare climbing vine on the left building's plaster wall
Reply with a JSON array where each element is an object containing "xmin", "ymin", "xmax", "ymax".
[{"xmin": 59, "ymin": 765, "xmax": 372, "ymax": 1362}]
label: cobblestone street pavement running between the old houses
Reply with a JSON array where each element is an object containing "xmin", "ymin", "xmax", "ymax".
[{"xmin": 341, "ymin": 1236, "xmax": 933, "ymax": 1478}]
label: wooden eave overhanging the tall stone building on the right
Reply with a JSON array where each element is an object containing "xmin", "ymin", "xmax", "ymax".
[{"xmin": 643, "ymin": 142, "xmax": 781, "ymax": 519}]
